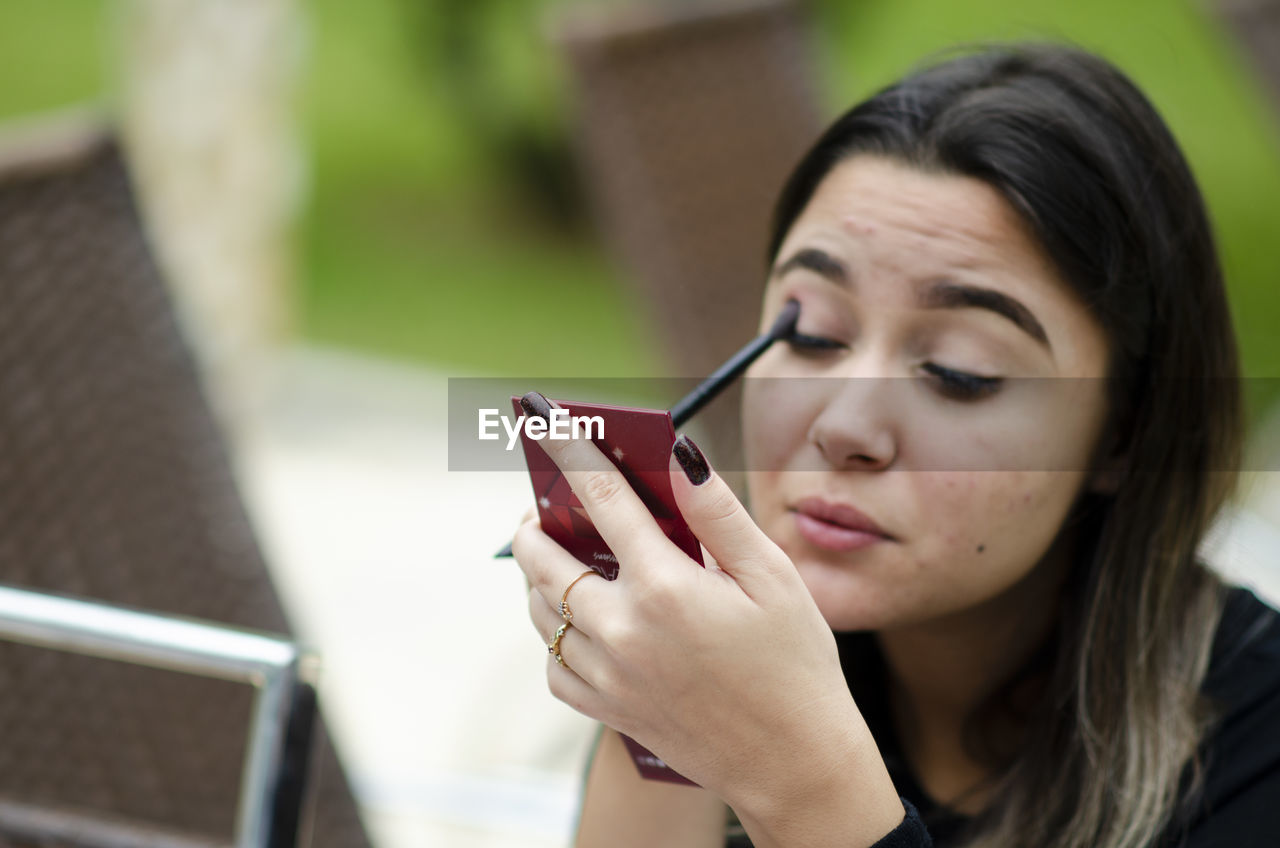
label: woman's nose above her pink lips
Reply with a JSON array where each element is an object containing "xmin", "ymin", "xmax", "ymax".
[{"xmin": 808, "ymin": 377, "xmax": 897, "ymax": 471}]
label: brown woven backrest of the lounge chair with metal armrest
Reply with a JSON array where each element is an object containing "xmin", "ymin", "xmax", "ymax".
[{"xmin": 0, "ymin": 116, "xmax": 369, "ymax": 848}]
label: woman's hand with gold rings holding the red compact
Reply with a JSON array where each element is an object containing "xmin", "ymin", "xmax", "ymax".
[{"xmin": 513, "ymin": 393, "xmax": 901, "ymax": 844}]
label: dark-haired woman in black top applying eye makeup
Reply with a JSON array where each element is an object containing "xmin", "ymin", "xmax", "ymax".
[{"xmin": 515, "ymin": 46, "xmax": 1280, "ymax": 848}]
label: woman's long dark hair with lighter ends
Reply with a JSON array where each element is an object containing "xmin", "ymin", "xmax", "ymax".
[{"xmin": 769, "ymin": 45, "xmax": 1243, "ymax": 848}]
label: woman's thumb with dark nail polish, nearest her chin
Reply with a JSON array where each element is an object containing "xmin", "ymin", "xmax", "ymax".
[{"xmin": 669, "ymin": 436, "xmax": 794, "ymax": 596}]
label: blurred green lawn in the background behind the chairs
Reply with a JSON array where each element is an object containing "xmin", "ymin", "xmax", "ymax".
[{"xmin": 0, "ymin": 0, "xmax": 1280, "ymax": 401}]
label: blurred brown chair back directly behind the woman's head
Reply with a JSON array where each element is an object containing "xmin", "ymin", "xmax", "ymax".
[{"xmin": 557, "ymin": 0, "xmax": 820, "ymax": 468}]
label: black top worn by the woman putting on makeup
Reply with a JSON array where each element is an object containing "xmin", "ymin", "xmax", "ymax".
[{"xmin": 726, "ymin": 589, "xmax": 1280, "ymax": 848}]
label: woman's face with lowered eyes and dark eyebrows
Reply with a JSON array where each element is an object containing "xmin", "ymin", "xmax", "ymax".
[{"xmin": 742, "ymin": 155, "xmax": 1107, "ymax": 630}]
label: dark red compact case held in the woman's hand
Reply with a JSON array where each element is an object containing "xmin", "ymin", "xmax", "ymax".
[{"xmin": 511, "ymin": 396, "xmax": 703, "ymax": 785}]
